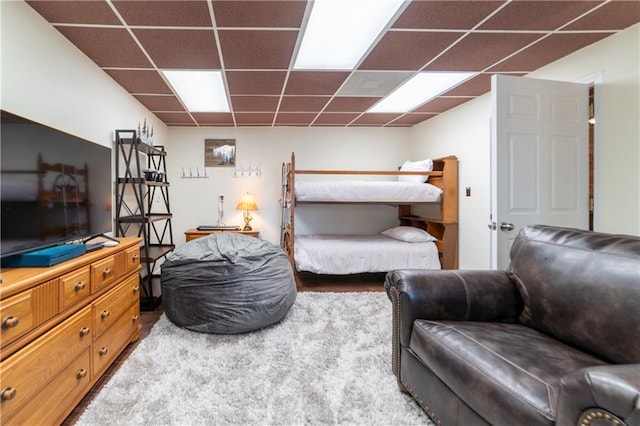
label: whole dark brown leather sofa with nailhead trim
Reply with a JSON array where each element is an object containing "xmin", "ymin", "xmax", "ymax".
[{"xmin": 385, "ymin": 226, "xmax": 640, "ymax": 426}]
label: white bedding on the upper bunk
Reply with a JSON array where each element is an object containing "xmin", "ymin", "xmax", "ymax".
[{"xmin": 295, "ymin": 180, "xmax": 442, "ymax": 203}]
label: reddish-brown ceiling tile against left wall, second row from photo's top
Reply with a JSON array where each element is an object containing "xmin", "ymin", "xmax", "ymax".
[{"xmin": 56, "ymin": 27, "xmax": 151, "ymax": 68}]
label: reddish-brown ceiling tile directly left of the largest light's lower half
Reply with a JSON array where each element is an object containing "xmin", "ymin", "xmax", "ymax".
[{"xmin": 218, "ymin": 30, "xmax": 298, "ymax": 69}]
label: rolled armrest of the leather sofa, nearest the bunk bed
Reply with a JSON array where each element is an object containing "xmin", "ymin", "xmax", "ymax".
[{"xmin": 384, "ymin": 269, "xmax": 523, "ymax": 346}]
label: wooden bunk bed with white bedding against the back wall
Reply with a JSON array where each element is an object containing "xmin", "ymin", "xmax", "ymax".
[{"xmin": 280, "ymin": 153, "xmax": 458, "ymax": 287}]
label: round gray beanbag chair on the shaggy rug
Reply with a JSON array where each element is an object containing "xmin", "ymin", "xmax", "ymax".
[{"xmin": 161, "ymin": 233, "xmax": 296, "ymax": 334}]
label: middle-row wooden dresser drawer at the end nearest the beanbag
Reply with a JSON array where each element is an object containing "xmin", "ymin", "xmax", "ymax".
[{"xmin": 93, "ymin": 274, "xmax": 140, "ymax": 338}]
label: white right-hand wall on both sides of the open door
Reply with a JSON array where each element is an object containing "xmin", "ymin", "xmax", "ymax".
[{"xmin": 411, "ymin": 24, "xmax": 640, "ymax": 269}]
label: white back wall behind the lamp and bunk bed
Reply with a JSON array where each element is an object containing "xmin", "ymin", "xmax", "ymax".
[{"xmin": 165, "ymin": 127, "xmax": 411, "ymax": 244}]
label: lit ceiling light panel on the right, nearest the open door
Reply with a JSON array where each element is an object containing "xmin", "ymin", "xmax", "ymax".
[{"xmin": 367, "ymin": 72, "xmax": 475, "ymax": 112}]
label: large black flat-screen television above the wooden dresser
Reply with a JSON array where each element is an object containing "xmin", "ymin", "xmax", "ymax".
[{"xmin": 0, "ymin": 110, "xmax": 113, "ymax": 258}]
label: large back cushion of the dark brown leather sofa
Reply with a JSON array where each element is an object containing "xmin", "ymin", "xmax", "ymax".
[{"xmin": 509, "ymin": 225, "xmax": 640, "ymax": 363}]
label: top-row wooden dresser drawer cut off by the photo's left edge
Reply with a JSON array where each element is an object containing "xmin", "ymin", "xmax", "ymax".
[{"xmin": 0, "ymin": 290, "xmax": 34, "ymax": 346}]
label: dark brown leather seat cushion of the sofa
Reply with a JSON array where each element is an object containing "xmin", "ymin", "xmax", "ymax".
[{"xmin": 410, "ymin": 320, "xmax": 605, "ymax": 425}]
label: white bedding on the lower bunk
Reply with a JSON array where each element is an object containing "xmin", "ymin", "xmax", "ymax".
[{"xmin": 294, "ymin": 235, "xmax": 440, "ymax": 275}]
